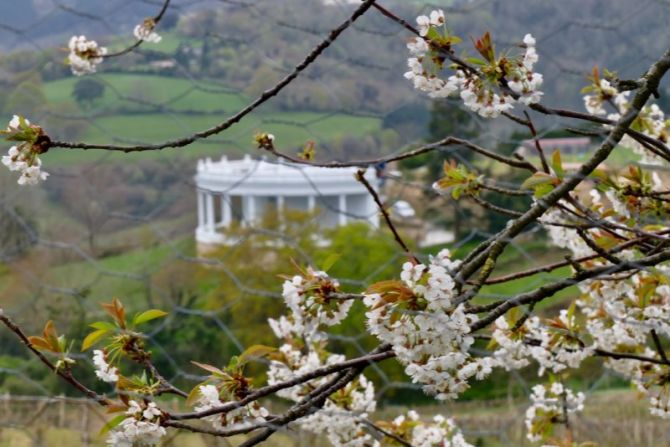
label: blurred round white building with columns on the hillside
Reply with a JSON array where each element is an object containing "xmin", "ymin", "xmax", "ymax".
[{"xmin": 195, "ymin": 155, "xmax": 379, "ymax": 246}]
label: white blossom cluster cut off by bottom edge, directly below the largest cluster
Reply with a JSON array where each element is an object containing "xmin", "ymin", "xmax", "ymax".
[{"xmin": 380, "ymin": 410, "xmax": 472, "ymax": 447}]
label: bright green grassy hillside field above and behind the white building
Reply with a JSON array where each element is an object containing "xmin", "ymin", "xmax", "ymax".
[{"xmin": 44, "ymin": 74, "xmax": 380, "ymax": 166}]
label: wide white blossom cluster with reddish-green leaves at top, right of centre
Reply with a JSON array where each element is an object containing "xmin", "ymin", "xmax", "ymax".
[{"xmin": 405, "ymin": 10, "xmax": 543, "ymax": 118}]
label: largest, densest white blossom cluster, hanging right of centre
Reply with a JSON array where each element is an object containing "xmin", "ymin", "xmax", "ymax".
[{"xmin": 364, "ymin": 250, "xmax": 496, "ymax": 399}]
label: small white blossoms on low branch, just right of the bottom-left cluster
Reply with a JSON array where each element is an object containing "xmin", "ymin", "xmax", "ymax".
[{"xmin": 194, "ymin": 385, "xmax": 269, "ymax": 430}]
